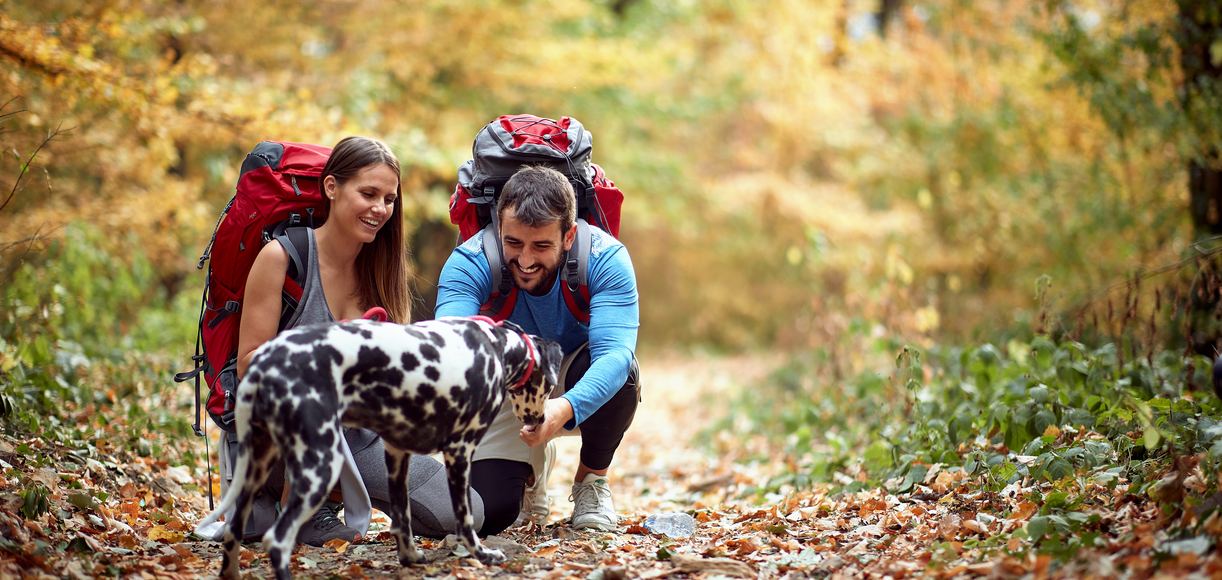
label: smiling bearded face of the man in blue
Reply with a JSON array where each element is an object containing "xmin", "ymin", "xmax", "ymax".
[{"xmin": 501, "ymin": 208, "xmax": 577, "ymax": 295}]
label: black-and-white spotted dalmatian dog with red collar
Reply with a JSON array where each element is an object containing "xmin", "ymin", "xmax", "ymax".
[{"xmin": 197, "ymin": 316, "xmax": 563, "ymax": 578}]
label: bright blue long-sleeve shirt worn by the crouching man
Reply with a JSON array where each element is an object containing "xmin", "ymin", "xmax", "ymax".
[{"xmin": 435, "ymin": 226, "xmax": 640, "ymax": 429}]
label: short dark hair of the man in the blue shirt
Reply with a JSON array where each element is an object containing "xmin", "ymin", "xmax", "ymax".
[{"xmin": 496, "ymin": 165, "xmax": 577, "ymax": 232}]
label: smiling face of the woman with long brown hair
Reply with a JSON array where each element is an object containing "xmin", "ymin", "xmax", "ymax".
[{"xmin": 323, "ymin": 164, "xmax": 398, "ymax": 243}]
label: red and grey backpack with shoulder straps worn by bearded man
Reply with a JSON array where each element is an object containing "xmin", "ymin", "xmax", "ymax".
[{"xmin": 450, "ymin": 115, "xmax": 623, "ymax": 324}]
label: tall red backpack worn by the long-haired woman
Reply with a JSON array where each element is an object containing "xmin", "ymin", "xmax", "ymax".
[{"xmin": 175, "ymin": 142, "xmax": 331, "ymax": 435}]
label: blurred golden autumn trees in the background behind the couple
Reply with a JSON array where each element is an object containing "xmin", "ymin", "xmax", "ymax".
[{"xmin": 0, "ymin": 0, "xmax": 1222, "ymax": 358}]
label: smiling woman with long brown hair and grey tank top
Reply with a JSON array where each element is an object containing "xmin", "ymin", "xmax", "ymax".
[{"xmin": 228, "ymin": 137, "xmax": 411, "ymax": 546}]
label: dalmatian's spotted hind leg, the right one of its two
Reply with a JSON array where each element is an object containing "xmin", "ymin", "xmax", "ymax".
[{"xmin": 263, "ymin": 419, "xmax": 343, "ymax": 579}]
